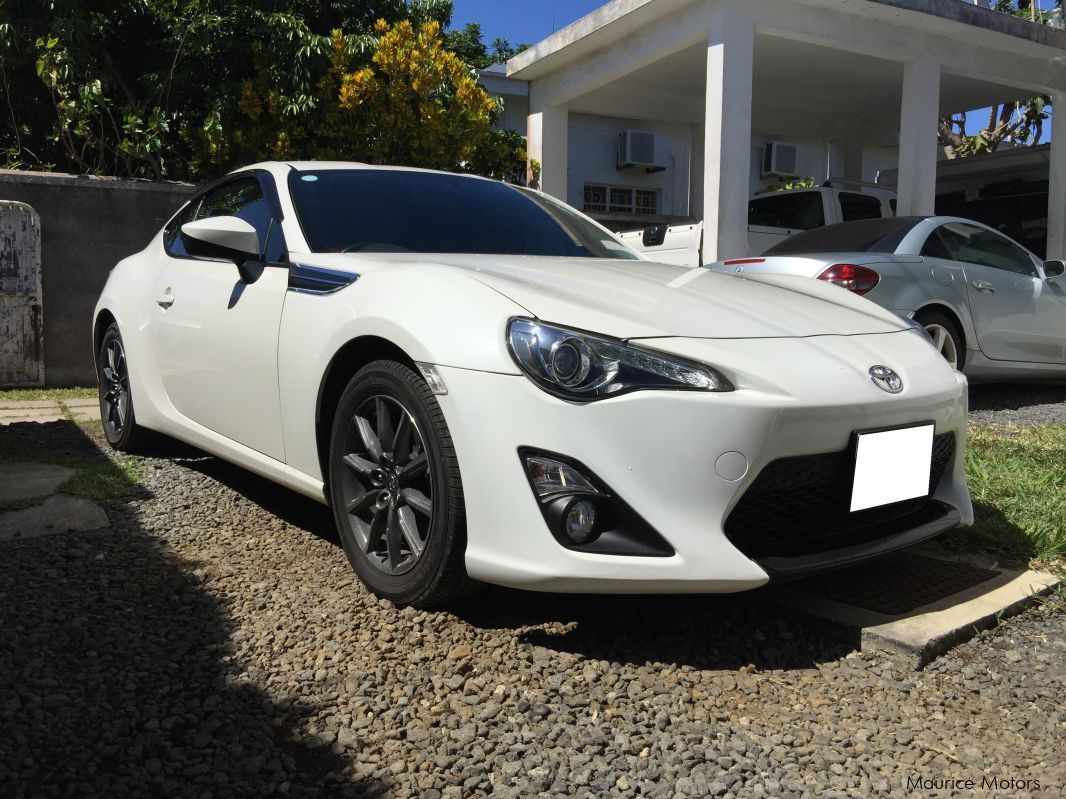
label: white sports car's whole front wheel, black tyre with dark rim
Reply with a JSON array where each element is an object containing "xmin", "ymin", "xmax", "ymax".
[{"xmin": 329, "ymin": 360, "xmax": 474, "ymax": 608}]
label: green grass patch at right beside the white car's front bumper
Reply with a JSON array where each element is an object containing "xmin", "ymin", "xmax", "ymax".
[{"xmin": 943, "ymin": 424, "xmax": 1066, "ymax": 570}]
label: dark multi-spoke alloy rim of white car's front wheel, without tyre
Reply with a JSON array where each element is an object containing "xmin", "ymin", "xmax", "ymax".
[{"xmin": 340, "ymin": 394, "xmax": 433, "ymax": 575}]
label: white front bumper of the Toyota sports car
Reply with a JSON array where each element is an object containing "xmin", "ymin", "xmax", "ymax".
[{"xmin": 438, "ymin": 332, "xmax": 972, "ymax": 593}]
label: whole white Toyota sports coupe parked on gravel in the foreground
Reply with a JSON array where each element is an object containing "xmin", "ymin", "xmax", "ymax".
[{"xmin": 93, "ymin": 163, "xmax": 972, "ymax": 606}]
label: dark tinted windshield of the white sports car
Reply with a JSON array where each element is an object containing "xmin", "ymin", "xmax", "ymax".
[{"xmin": 289, "ymin": 169, "xmax": 640, "ymax": 260}]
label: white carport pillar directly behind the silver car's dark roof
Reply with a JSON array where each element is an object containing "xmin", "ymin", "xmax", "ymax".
[{"xmin": 897, "ymin": 56, "xmax": 940, "ymax": 216}]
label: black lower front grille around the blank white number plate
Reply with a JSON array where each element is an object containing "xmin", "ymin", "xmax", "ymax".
[{"xmin": 725, "ymin": 433, "xmax": 955, "ymax": 559}]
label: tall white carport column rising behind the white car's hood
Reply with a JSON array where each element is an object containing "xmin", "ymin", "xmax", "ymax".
[{"xmin": 704, "ymin": 5, "xmax": 755, "ymax": 263}]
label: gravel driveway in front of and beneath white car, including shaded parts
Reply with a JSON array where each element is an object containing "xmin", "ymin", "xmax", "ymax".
[{"xmin": 0, "ymin": 413, "xmax": 1066, "ymax": 799}]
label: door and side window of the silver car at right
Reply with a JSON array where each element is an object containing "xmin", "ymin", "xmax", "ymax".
[{"xmin": 937, "ymin": 222, "xmax": 1066, "ymax": 363}]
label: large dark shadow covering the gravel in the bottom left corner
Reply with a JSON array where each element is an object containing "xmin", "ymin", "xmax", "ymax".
[{"xmin": 0, "ymin": 423, "xmax": 372, "ymax": 799}]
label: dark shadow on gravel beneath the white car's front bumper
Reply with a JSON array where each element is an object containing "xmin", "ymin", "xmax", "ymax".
[{"xmin": 451, "ymin": 587, "xmax": 858, "ymax": 670}]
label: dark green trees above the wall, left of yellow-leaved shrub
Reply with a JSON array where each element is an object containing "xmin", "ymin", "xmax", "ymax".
[{"xmin": 0, "ymin": 0, "xmax": 520, "ymax": 180}]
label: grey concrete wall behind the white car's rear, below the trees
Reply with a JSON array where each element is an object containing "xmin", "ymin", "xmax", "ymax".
[{"xmin": 0, "ymin": 169, "xmax": 195, "ymax": 387}]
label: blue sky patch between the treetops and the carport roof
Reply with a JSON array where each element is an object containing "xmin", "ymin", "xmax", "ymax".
[{"xmin": 452, "ymin": 0, "xmax": 607, "ymax": 45}]
